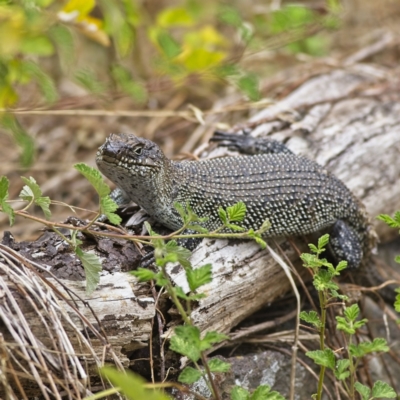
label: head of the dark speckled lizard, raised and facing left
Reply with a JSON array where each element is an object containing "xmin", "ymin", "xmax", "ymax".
[{"xmin": 96, "ymin": 133, "xmax": 167, "ymax": 186}]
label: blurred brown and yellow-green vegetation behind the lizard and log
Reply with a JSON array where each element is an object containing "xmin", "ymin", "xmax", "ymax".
[{"xmin": 0, "ymin": 0, "xmax": 400, "ymax": 240}]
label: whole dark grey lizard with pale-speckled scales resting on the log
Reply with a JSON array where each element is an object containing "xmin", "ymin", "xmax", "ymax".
[{"xmin": 96, "ymin": 132, "xmax": 373, "ymax": 268}]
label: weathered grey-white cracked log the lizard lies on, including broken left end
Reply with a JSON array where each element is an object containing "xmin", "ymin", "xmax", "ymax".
[{"xmin": 0, "ymin": 66, "xmax": 400, "ymax": 396}]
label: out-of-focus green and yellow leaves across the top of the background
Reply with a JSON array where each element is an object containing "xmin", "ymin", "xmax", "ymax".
[{"xmin": 0, "ymin": 0, "xmax": 341, "ymax": 166}]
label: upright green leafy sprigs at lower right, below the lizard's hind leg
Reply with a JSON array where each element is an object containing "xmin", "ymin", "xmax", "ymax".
[{"xmin": 300, "ymin": 235, "xmax": 396, "ymax": 400}]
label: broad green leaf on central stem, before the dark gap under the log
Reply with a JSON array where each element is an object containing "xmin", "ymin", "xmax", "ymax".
[{"xmin": 170, "ymin": 326, "xmax": 201, "ymax": 362}]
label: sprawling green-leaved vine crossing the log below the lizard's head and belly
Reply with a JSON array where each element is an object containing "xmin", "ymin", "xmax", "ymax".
[{"xmin": 0, "ymin": 163, "xmax": 283, "ymax": 400}]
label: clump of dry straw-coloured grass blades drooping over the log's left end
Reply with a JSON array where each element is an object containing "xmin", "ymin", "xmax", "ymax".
[{"xmin": 0, "ymin": 249, "xmax": 119, "ymax": 399}]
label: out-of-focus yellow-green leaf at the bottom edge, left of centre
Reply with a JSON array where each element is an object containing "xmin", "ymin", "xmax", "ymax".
[{"xmin": 100, "ymin": 367, "xmax": 171, "ymax": 400}]
